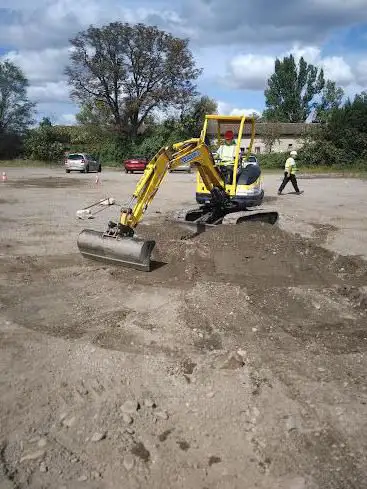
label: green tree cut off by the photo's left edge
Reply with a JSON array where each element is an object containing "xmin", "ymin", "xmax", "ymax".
[{"xmin": 0, "ymin": 60, "xmax": 35, "ymax": 135}]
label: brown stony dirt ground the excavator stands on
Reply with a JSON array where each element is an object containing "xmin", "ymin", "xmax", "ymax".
[{"xmin": 0, "ymin": 169, "xmax": 367, "ymax": 489}]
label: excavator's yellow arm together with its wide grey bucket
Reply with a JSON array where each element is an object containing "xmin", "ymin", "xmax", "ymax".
[{"xmin": 77, "ymin": 138, "xmax": 229, "ymax": 271}]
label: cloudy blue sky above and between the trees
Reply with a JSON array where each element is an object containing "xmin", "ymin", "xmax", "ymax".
[{"xmin": 0, "ymin": 0, "xmax": 367, "ymax": 124}]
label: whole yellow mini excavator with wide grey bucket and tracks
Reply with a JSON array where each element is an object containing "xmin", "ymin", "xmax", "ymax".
[{"xmin": 77, "ymin": 115, "xmax": 279, "ymax": 271}]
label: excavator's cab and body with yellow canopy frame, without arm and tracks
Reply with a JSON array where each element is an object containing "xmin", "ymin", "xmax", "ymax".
[{"xmin": 196, "ymin": 115, "xmax": 264, "ymax": 210}]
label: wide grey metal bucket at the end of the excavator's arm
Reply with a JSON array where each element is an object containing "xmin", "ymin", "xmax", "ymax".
[{"xmin": 77, "ymin": 229, "xmax": 155, "ymax": 272}]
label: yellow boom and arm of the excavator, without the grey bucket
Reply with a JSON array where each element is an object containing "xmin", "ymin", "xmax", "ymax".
[{"xmin": 120, "ymin": 138, "xmax": 227, "ymax": 235}]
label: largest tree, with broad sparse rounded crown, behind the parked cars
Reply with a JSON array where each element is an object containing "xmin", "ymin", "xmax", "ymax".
[{"xmin": 66, "ymin": 22, "xmax": 201, "ymax": 139}]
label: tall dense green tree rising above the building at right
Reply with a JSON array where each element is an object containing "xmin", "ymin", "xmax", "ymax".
[{"xmin": 263, "ymin": 55, "xmax": 325, "ymax": 122}]
